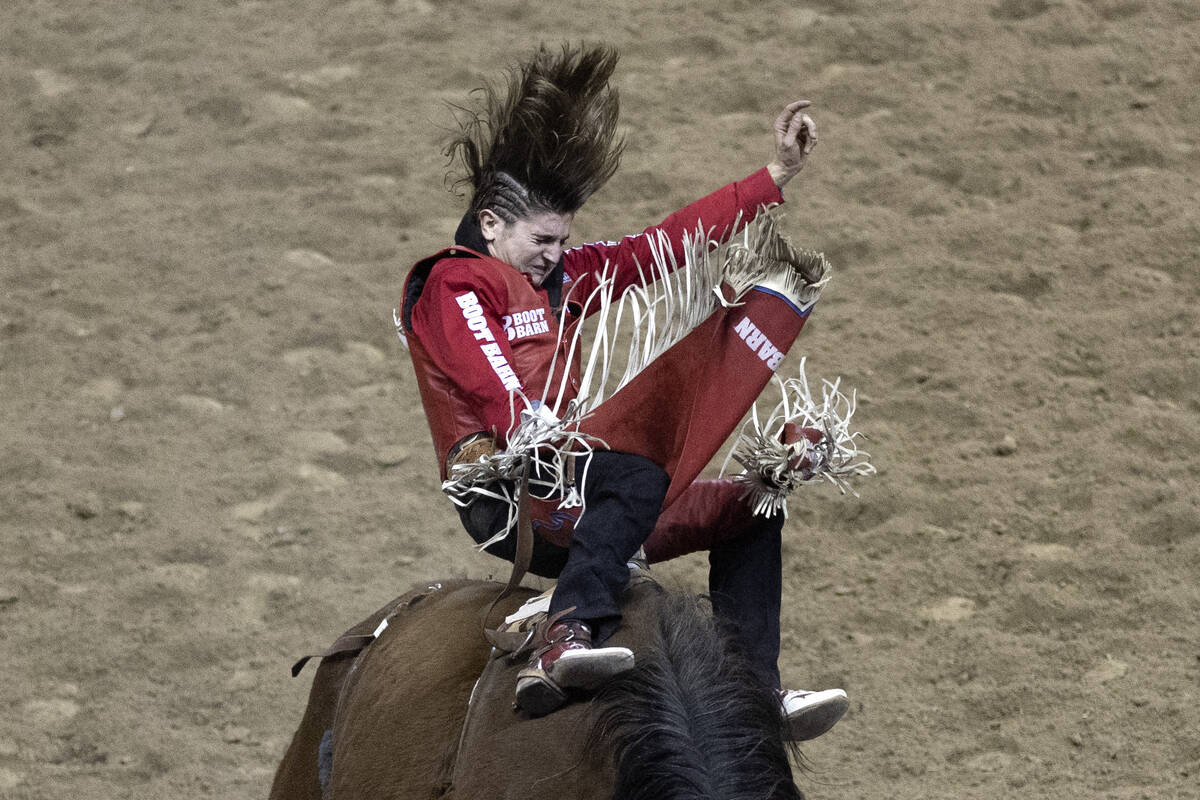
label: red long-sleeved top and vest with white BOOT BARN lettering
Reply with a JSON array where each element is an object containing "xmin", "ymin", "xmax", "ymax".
[{"xmin": 401, "ymin": 169, "xmax": 782, "ymax": 479}]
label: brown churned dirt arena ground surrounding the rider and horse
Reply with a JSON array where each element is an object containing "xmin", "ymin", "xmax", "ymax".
[{"xmin": 0, "ymin": 0, "xmax": 1200, "ymax": 800}]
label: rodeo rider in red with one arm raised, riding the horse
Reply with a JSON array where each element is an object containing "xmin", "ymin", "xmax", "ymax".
[{"xmin": 397, "ymin": 47, "xmax": 847, "ymax": 740}]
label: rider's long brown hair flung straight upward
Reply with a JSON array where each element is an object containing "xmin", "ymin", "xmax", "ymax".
[{"xmin": 445, "ymin": 44, "xmax": 624, "ymax": 222}]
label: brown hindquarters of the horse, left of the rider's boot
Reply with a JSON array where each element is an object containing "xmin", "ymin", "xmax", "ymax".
[{"xmin": 271, "ymin": 581, "xmax": 532, "ymax": 800}]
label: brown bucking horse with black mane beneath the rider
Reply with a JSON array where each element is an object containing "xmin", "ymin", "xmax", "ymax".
[{"xmin": 271, "ymin": 581, "xmax": 803, "ymax": 800}]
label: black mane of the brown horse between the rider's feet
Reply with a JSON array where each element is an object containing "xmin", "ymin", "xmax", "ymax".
[{"xmin": 589, "ymin": 591, "xmax": 803, "ymax": 800}]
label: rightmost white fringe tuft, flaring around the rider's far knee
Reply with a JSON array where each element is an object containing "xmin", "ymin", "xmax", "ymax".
[{"xmin": 721, "ymin": 359, "xmax": 875, "ymax": 516}]
